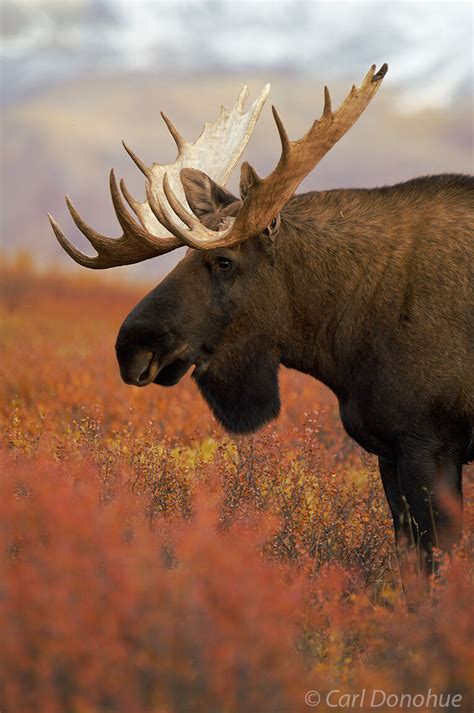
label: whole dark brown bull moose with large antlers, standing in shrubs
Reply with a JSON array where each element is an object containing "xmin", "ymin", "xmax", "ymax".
[{"xmin": 50, "ymin": 64, "xmax": 474, "ymax": 569}]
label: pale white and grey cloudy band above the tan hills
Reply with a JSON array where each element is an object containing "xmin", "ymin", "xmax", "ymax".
[{"xmin": 1, "ymin": 0, "xmax": 473, "ymax": 112}]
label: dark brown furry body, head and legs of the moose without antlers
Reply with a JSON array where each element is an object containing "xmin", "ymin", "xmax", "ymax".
[{"xmin": 117, "ymin": 175, "xmax": 474, "ymax": 565}]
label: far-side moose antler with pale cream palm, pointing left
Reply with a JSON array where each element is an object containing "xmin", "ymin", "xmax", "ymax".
[{"xmin": 48, "ymin": 84, "xmax": 270, "ymax": 269}]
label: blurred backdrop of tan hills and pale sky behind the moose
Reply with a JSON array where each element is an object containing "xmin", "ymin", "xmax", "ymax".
[{"xmin": 0, "ymin": 0, "xmax": 473, "ymax": 280}]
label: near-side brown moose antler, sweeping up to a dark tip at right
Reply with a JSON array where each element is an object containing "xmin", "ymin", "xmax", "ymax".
[{"xmin": 147, "ymin": 64, "xmax": 388, "ymax": 250}]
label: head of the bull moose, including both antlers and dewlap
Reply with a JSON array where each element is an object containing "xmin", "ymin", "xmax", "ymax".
[{"xmin": 50, "ymin": 64, "xmax": 387, "ymax": 433}]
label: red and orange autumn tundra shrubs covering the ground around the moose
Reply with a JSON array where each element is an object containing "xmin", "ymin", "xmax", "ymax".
[{"xmin": 0, "ymin": 259, "xmax": 474, "ymax": 713}]
